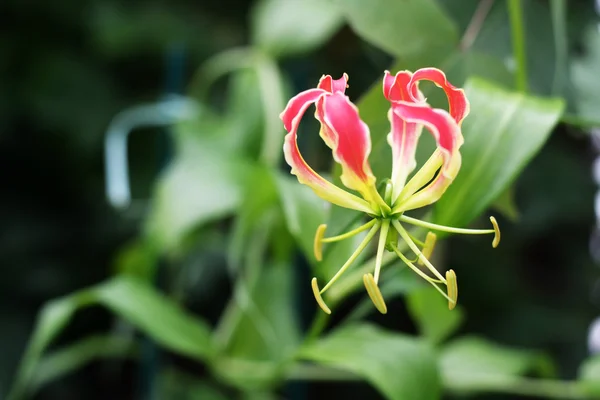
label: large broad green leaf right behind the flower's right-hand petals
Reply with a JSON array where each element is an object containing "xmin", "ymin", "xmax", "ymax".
[{"xmin": 434, "ymin": 79, "xmax": 564, "ymax": 226}]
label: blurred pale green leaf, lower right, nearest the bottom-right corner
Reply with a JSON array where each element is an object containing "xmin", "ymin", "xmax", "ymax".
[{"xmin": 440, "ymin": 336, "xmax": 549, "ymax": 391}]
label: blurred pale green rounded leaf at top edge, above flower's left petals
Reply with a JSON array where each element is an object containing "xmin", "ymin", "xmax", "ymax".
[{"xmin": 251, "ymin": 0, "xmax": 344, "ymax": 56}]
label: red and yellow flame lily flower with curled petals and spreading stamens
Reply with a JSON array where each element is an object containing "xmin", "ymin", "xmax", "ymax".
[{"xmin": 280, "ymin": 68, "xmax": 500, "ymax": 314}]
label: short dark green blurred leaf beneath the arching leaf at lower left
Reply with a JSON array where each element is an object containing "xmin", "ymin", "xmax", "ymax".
[{"xmin": 31, "ymin": 336, "xmax": 135, "ymax": 392}]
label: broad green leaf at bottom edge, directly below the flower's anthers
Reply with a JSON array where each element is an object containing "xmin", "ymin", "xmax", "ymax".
[{"xmin": 300, "ymin": 324, "xmax": 441, "ymax": 400}]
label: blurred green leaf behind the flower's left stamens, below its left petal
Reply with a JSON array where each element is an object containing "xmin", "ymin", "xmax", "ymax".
[{"xmin": 276, "ymin": 175, "xmax": 327, "ymax": 262}]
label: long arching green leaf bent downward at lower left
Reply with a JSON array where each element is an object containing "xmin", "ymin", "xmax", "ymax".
[{"xmin": 8, "ymin": 276, "xmax": 214, "ymax": 400}]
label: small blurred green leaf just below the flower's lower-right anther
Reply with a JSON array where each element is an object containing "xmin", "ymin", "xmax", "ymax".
[{"xmin": 406, "ymin": 287, "xmax": 464, "ymax": 344}]
